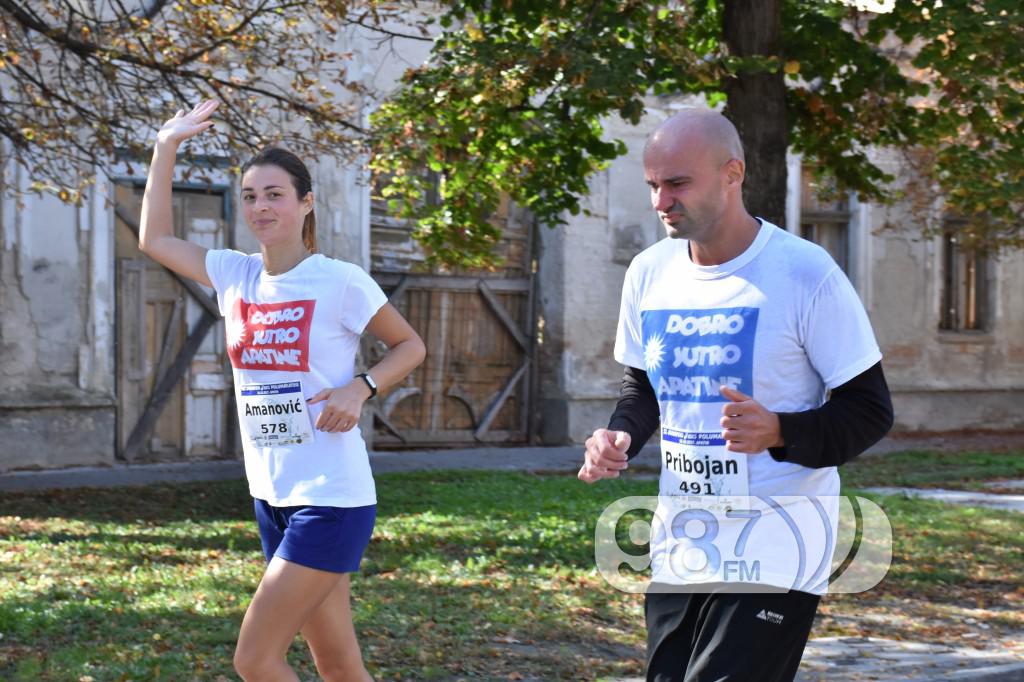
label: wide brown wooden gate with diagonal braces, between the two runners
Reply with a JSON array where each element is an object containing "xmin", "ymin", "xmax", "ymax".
[{"xmin": 365, "ymin": 191, "xmax": 536, "ymax": 447}]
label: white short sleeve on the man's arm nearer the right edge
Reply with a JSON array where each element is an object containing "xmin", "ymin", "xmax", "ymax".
[{"xmin": 803, "ymin": 267, "xmax": 882, "ymax": 390}]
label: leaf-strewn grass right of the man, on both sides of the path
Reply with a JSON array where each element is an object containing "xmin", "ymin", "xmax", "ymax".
[{"xmin": 814, "ymin": 451, "xmax": 1024, "ymax": 655}]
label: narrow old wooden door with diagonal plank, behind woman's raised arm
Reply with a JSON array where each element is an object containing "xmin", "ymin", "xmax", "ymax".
[{"xmin": 116, "ymin": 184, "xmax": 233, "ymax": 461}]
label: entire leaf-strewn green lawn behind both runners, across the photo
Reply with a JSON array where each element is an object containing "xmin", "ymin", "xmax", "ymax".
[{"xmin": 0, "ymin": 453, "xmax": 1024, "ymax": 682}]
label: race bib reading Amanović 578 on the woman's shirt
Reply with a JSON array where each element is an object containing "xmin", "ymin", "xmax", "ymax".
[{"xmin": 239, "ymin": 381, "xmax": 313, "ymax": 447}]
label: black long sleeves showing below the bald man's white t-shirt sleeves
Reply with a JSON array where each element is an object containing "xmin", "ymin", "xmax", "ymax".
[{"xmin": 608, "ymin": 363, "xmax": 893, "ymax": 469}]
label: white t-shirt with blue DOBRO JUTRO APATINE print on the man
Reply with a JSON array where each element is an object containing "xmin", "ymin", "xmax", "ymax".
[{"xmin": 614, "ymin": 221, "xmax": 882, "ymax": 593}]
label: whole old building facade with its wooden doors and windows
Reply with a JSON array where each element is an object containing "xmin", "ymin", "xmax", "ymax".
[{"xmin": 0, "ymin": 49, "xmax": 1024, "ymax": 471}]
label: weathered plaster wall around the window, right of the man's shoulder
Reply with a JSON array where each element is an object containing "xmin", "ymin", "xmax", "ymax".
[{"xmin": 869, "ymin": 153, "xmax": 1024, "ymax": 431}]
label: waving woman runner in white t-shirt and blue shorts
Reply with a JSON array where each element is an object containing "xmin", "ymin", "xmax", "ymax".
[{"xmin": 139, "ymin": 100, "xmax": 425, "ymax": 682}]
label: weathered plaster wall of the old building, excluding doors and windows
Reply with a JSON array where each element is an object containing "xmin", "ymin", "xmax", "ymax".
[{"xmin": 9, "ymin": 17, "xmax": 1024, "ymax": 471}]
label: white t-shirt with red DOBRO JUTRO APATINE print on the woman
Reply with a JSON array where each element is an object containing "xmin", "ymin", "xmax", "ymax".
[{"xmin": 206, "ymin": 250, "xmax": 387, "ymax": 507}]
